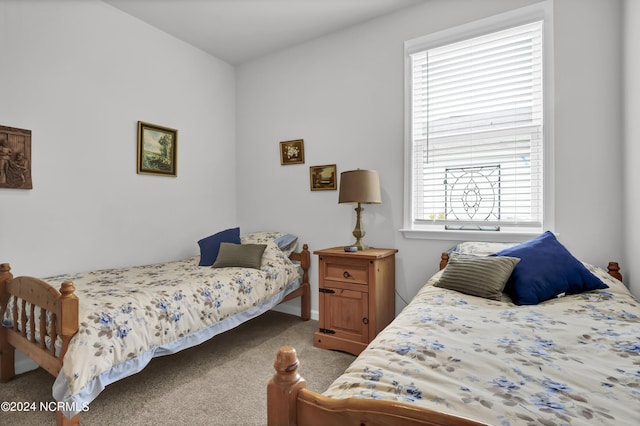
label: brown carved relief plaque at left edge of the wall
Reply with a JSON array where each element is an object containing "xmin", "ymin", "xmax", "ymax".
[{"xmin": 0, "ymin": 126, "xmax": 33, "ymax": 189}]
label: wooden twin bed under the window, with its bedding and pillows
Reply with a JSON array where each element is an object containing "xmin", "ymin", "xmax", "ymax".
[{"xmin": 267, "ymin": 235, "xmax": 640, "ymax": 426}]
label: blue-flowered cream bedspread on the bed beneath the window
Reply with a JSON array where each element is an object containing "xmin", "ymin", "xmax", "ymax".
[{"xmin": 325, "ymin": 266, "xmax": 640, "ymax": 425}]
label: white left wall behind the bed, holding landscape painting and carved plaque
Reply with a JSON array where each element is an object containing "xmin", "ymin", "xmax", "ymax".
[{"xmin": 0, "ymin": 0, "xmax": 236, "ymax": 276}]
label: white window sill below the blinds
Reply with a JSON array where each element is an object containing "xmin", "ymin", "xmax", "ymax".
[{"xmin": 400, "ymin": 227, "xmax": 544, "ymax": 243}]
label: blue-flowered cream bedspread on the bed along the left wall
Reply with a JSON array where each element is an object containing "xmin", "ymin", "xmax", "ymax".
[{"xmin": 5, "ymin": 241, "xmax": 301, "ymax": 416}]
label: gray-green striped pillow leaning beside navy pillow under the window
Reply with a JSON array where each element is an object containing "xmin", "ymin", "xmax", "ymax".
[{"xmin": 434, "ymin": 253, "xmax": 520, "ymax": 300}]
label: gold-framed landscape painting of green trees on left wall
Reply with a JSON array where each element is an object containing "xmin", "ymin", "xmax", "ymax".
[{"xmin": 138, "ymin": 121, "xmax": 178, "ymax": 176}]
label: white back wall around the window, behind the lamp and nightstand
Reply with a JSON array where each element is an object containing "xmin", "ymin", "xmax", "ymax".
[{"xmin": 236, "ymin": 0, "xmax": 624, "ymax": 320}]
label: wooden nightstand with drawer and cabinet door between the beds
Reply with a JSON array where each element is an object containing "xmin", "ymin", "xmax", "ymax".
[{"xmin": 313, "ymin": 247, "xmax": 398, "ymax": 355}]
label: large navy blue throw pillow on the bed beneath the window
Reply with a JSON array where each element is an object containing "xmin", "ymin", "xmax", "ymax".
[{"xmin": 494, "ymin": 231, "xmax": 609, "ymax": 305}]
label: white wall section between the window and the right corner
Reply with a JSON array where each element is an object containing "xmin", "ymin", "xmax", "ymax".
[{"xmin": 554, "ymin": 0, "xmax": 628, "ymax": 273}]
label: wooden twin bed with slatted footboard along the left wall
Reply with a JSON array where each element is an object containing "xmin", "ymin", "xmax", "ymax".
[{"xmin": 0, "ymin": 229, "xmax": 310, "ymax": 424}]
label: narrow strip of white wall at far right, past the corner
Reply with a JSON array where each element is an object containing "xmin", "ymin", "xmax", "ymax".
[{"xmin": 623, "ymin": 0, "xmax": 640, "ymax": 297}]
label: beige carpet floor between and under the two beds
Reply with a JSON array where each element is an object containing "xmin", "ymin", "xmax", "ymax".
[{"xmin": 0, "ymin": 311, "xmax": 355, "ymax": 426}]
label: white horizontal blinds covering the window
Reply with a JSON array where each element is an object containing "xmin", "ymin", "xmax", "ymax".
[{"xmin": 410, "ymin": 21, "xmax": 543, "ymax": 229}]
